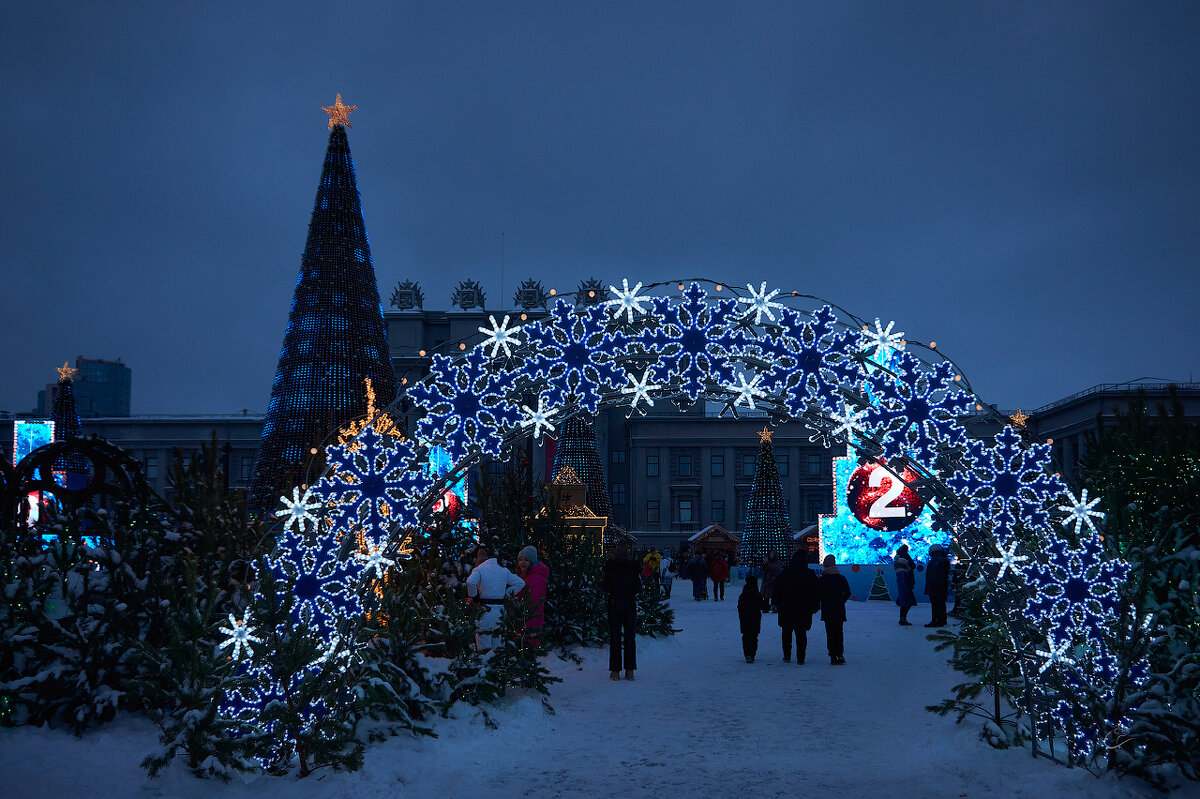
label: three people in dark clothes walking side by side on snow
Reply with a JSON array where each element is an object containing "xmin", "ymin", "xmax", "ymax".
[{"xmin": 738, "ymin": 552, "xmax": 850, "ymax": 666}]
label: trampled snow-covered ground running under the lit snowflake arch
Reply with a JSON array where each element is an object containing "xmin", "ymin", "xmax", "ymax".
[{"xmin": 0, "ymin": 582, "xmax": 1200, "ymax": 799}]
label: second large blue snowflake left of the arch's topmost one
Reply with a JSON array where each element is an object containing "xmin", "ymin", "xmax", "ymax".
[{"xmin": 409, "ymin": 347, "xmax": 520, "ymax": 461}]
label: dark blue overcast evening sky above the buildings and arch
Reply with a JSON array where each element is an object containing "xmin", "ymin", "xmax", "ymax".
[{"xmin": 0, "ymin": 6, "xmax": 1200, "ymax": 413}]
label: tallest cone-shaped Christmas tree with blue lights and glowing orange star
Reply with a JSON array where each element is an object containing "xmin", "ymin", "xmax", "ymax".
[{"xmin": 250, "ymin": 95, "xmax": 396, "ymax": 511}]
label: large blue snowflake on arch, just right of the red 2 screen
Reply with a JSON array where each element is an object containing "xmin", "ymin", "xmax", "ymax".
[{"xmin": 946, "ymin": 426, "xmax": 1063, "ymax": 530}]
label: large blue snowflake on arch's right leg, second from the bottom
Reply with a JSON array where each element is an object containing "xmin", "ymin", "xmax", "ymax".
[{"xmin": 1022, "ymin": 536, "xmax": 1129, "ymax": 637}]
